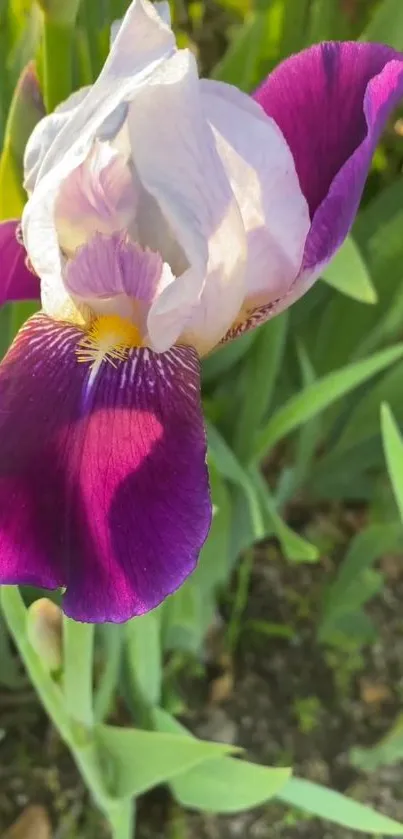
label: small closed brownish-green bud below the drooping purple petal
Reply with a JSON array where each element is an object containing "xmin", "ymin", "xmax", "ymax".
[{"xmin": 27, "ymin": 597, "xmax": 63, "ymax": 673}]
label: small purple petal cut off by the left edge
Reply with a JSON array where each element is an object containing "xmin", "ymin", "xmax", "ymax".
[{"xmin": 0, "ymin": 221, "xmax": 40, "ymax": 306}]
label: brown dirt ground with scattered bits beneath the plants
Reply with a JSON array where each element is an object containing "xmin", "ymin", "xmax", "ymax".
[{"xmin": 0, "ymin": 512, "xmax": 403, "ymax": 839}]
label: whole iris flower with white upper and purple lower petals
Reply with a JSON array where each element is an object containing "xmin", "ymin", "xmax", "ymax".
[{"xmin": 0, "ymin": 0, "xmax": 403, "ymax": 622}]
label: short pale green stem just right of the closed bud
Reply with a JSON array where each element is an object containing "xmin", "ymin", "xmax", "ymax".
[{"xmin": 63, "ymin": 617, "xmax": 94, "ymax": 728}]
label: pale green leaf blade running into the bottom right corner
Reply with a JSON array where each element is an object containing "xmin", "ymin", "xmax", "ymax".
[{"xmin": 276, "ymin": 778, "xmax": 403, "ymax": 836}]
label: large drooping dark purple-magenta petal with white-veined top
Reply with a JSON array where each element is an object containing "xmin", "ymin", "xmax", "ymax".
[{"xmin": 0, "ymin": 315, "xmax": 211, "ymax": 622}]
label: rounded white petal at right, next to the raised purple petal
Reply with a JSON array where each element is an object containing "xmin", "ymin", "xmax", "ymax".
[{"xmin": 201, "ymin": 81, "xmax": 310, "ymax": 302}]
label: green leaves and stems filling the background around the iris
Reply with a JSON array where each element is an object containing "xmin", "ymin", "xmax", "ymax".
[{"xmin": 0, "ymin": 0, "xmax": 403, "ymax": 837}]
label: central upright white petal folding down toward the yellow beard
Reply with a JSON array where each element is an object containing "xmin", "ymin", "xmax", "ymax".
[{"xmin": 128, "ymin": 50, "xmax": 246, "ymax": 351}]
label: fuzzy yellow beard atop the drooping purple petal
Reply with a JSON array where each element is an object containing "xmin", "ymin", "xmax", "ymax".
[{"xmin": 76, "ymin": 315, "xmax": 142, "ymax": 374}]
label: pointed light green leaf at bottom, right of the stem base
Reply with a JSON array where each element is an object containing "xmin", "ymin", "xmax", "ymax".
[{"xmin": 94, "ymin": 725, "xmax": 234, "ymax": 798}]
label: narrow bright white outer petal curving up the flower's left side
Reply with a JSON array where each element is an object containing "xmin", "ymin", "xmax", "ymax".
[{"xmin": 22, "ymin": 0, "xmax": 175, "ymax": 314}]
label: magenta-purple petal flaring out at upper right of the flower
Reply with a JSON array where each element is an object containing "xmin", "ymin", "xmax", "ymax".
[{"xmin": 254, "ymin": 42, "xmax": 403, "ymax": 272}]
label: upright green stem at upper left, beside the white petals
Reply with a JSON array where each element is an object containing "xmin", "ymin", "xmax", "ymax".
[{"xmin": 43, "ymin": 16, "xmax": 74, "ymax": 113}]
